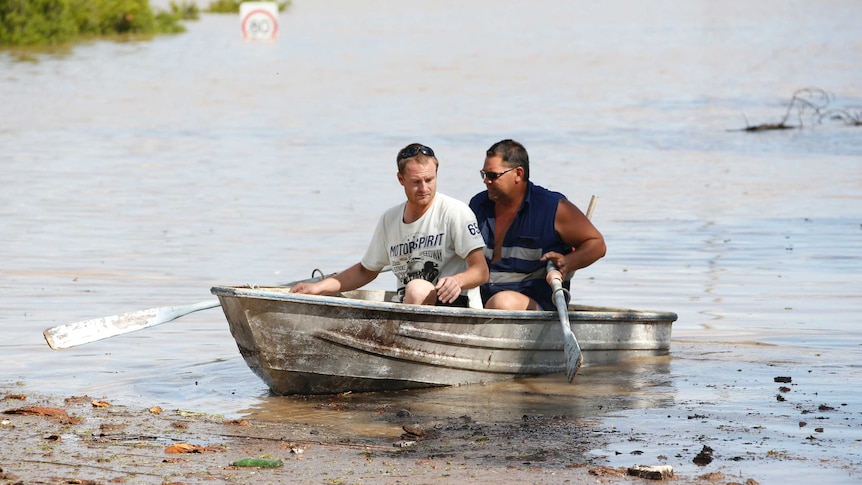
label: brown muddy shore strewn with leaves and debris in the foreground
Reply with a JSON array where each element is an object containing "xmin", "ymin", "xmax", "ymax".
[{"xmin": 0, "ymin": 389, "xmax": 640, "ymax": 485}]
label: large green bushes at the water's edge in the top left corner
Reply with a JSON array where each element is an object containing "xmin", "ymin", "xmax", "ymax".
[{"xmin": 0, "ymin": 0, "xmax": 199, "ymax": 47}]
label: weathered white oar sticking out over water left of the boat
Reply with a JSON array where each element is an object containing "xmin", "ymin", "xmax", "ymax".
[{"xmin": 42, "ymin": 300, "xmax": 220, "ymax": 350}]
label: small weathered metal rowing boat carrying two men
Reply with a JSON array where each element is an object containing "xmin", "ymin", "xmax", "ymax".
[{"xmin": 211, "ymin": 286, "xmax": 677, "ymax": 395}]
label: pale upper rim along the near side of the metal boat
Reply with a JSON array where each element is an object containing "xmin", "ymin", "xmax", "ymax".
[{"xmin": 210, "ymin": 285, "xmax": 678, "ymax": 323}]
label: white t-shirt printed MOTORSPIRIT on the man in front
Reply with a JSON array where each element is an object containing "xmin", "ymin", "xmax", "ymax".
[{"xmin": 361, "ymin": 192, "xmax": 485, "ymax": 308}]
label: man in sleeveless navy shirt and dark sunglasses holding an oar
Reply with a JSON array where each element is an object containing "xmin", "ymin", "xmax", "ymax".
[{"xmin": 470, "ymin": 140, "xmax": 606, "ymax": 310}]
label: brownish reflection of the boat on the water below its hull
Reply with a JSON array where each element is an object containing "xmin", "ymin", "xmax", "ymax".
[{"xmin": 241, "ymin": 356, "xmax": 675, "ymax": 437}]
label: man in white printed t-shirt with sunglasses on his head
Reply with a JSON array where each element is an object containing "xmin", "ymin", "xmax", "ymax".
[{"xmin": 291, "ymin": 143, "xmax": 489, "ymax": 308}]
